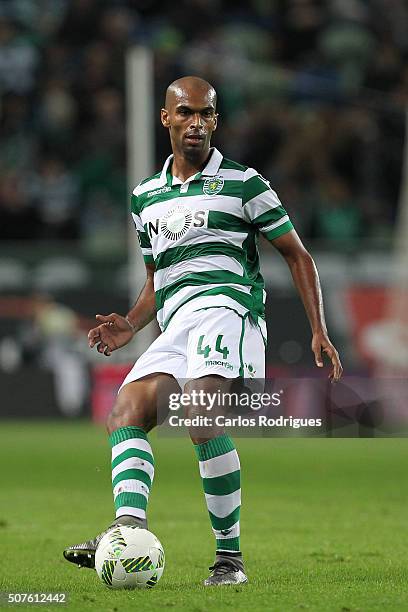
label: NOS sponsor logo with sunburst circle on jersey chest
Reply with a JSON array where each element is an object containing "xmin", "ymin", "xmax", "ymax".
[{"xmin": 147, "ymin": 204, "xmax": 208, "ymax": 240}]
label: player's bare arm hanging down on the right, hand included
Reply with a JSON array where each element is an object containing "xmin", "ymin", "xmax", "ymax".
[{"xmin": 270, "ymin": 230, "xmax": 343, "ymax": 381}]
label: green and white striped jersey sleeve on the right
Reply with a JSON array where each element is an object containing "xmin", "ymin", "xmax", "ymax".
[{"xmin": 242, "ymin": 168, "xmax": 293, "ymax": 240}]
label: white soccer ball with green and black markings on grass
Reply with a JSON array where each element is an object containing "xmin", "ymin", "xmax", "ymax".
[{"xmin": 95, "ymin": 525, "xmax": 164, "ymax": 589}]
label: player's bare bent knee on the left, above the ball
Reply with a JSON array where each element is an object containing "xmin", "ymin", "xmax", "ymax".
[{"xmin": 106, "ymin": 385, "xmax": 156, "ymax": 434}]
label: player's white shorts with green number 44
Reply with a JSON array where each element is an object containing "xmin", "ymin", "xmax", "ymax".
[{"xmin": 122, "ymin": 302, "xmax": 266, "ymax": 387}]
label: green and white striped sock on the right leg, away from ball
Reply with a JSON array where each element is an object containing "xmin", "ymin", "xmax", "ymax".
[{"xmin": 194, "ymin": 434, "xmax": 241, "ymax": 554}]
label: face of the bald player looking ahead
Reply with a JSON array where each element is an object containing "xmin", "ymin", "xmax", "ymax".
[{"xmin": 161, "ymin": 87, "xmax": 217, "ymax": 158}]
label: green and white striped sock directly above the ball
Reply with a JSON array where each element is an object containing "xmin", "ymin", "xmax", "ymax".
[{"xmin": 109, "ymin": 427, "xmax": 154, "ymax": 520}]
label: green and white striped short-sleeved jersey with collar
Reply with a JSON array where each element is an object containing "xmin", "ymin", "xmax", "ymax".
[{"xmin": 132, "ymin": 148, "xmax": 293, "ymax": 330}]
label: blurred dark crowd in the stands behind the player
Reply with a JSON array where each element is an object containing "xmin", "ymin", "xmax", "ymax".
[{"xmin": 0, "ymin": 0, "xmax": 408, "ymax": 248}]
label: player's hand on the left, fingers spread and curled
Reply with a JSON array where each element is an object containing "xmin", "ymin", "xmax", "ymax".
[{"xmin": 88, "ymin": 312, "xmax": 134, "ymax": 357}]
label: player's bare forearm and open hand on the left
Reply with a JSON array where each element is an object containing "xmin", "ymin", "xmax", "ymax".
[{"xmin": 88, "ymin": 263, "xmax": 156, "ymax": 357}]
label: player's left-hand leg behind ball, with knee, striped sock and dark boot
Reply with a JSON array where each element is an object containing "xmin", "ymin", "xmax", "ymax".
[{"xmin": 64, "ymin": 374, "xmax": 176, "ymax": 568}]
